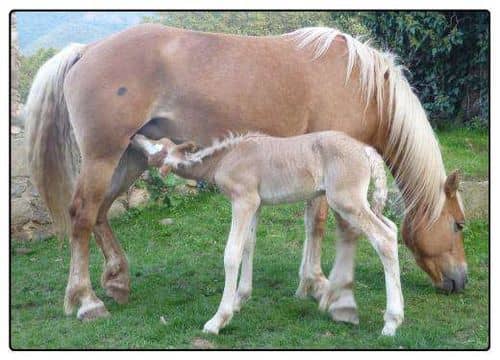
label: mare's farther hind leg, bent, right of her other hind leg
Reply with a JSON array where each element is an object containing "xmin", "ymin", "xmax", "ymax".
[{"xmin": 94, "ymin": 148, "xmax": 147, "ymax": 304}]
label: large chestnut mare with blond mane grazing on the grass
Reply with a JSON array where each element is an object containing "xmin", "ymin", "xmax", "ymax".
[{"xmin": 26, "ymin": 24, "xmax": 467, "ymax": 319}]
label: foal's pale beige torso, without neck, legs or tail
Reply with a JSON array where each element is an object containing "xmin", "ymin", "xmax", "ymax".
[{"xmin": 216, "ymin": 131, "xmax": 370, "ymax": 204}]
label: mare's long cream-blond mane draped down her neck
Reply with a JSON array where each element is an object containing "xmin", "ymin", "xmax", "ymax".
[{"xmin": 283, "ymin": 27, "xmax": 446, "ymax": 224}]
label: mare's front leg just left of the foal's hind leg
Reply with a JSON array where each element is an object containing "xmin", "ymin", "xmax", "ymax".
[{"xmin": 319, "ymin": 213, "xmax": 360, "ymax": 325}]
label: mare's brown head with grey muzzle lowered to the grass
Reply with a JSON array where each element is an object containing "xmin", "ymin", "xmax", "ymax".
[{"xmin": 402, "ymin": 171, "xmax": 467, "ymax": 292}]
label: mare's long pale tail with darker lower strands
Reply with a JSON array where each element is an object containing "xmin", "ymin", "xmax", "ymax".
[{"xmin": 24, "ymin": 44, "xmax": 85, "ymax": 237}]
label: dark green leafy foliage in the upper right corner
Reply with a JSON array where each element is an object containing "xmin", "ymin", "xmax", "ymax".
[{"xmin": 360, "ymin": 11, "xmax": 489, "ymax": 127}]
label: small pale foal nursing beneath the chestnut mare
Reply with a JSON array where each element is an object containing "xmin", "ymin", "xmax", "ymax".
[{"xmin": 132, "ymin": 131, "xmax": 403, "ymax": 335}]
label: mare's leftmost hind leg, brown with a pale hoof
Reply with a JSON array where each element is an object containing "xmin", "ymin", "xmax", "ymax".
[{"xmin": 64, "ymin": 156, "xmax": 123, "ymax": 320}]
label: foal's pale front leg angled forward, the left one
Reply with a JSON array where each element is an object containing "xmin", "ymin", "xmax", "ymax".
[{"xmin": 203, "ymin": 196, "xmax": 260, "ymax": 334}]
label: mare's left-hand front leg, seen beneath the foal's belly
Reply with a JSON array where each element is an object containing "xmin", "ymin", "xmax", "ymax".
[{"xmin": 295, "ymin": 196, "xmax": 328, "ymax": 300}]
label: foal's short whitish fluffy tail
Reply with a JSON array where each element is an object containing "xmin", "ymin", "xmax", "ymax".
[{"xmin": 365, "ymin": 146, "xmax": 387, "ymax": 217}]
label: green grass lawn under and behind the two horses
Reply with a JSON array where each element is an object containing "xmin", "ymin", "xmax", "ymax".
[{"xmin": 11, "ymin": 128, "xmax": 489, "ymax": 349}]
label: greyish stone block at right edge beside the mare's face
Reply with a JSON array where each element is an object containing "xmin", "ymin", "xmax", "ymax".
[{"xmin": 459, "ymin": 181, "xmax": 489, "ymax": 219}]
